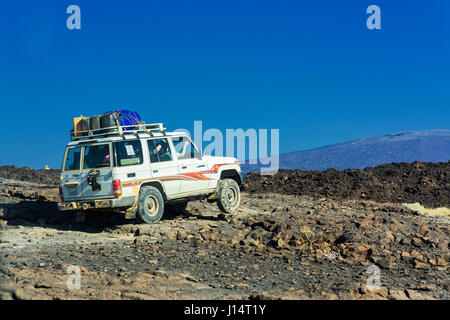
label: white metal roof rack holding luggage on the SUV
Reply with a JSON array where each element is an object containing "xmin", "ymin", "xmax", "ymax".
[{"xmin": 70, "ymin": 123, "xmax": 166, "ymax": 141}]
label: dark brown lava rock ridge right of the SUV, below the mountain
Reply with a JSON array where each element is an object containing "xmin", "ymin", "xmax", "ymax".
[{"xmin": 245, "ymin": 161, "xmax": 450, "ymax": 208}]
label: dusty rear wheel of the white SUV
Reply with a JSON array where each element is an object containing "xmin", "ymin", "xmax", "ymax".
[{"xmin": 136, "ymin": 186, "xmax": 164, "ymax": 223}]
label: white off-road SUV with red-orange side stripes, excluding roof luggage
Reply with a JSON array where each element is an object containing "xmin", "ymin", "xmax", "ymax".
[{"xmin": 58, "ymin": 123, "xmax": 245, "ymax": 223}]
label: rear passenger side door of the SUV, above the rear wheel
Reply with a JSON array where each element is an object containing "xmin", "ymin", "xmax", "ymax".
[{"xmin": 147, "ymin": 138, "xmax": 180, "ymax": 197}]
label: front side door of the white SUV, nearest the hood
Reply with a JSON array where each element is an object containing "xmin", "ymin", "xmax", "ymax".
[{"xmin": 172, "ymin": 136, "xmax": 209, "ymax": 193}]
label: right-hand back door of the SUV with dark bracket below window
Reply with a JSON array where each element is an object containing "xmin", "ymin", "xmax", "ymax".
[{"xmin": 81, "ymin": 143, "xmax": 114, "ymax": 199}]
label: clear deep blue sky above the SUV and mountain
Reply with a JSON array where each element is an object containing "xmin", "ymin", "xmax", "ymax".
[{"xmin": 0, "ymin": 0, "xmax": 450, "ymax": 168}]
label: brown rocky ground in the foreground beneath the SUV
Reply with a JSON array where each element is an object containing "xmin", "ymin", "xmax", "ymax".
[{"xmin": 0, "ymin": 168, "xmax": 450, "ymax": 299}]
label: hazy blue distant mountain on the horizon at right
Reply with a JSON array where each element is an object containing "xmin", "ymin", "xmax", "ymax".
[{"xmin": 242, "ymin": 129, "xmax": 450, "ymax": 171}]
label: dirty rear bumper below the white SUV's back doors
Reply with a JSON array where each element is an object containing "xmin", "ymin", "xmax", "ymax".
[{"xmin": 58, "ymin": 196, "xmax": 136, "ymax": 211}]
